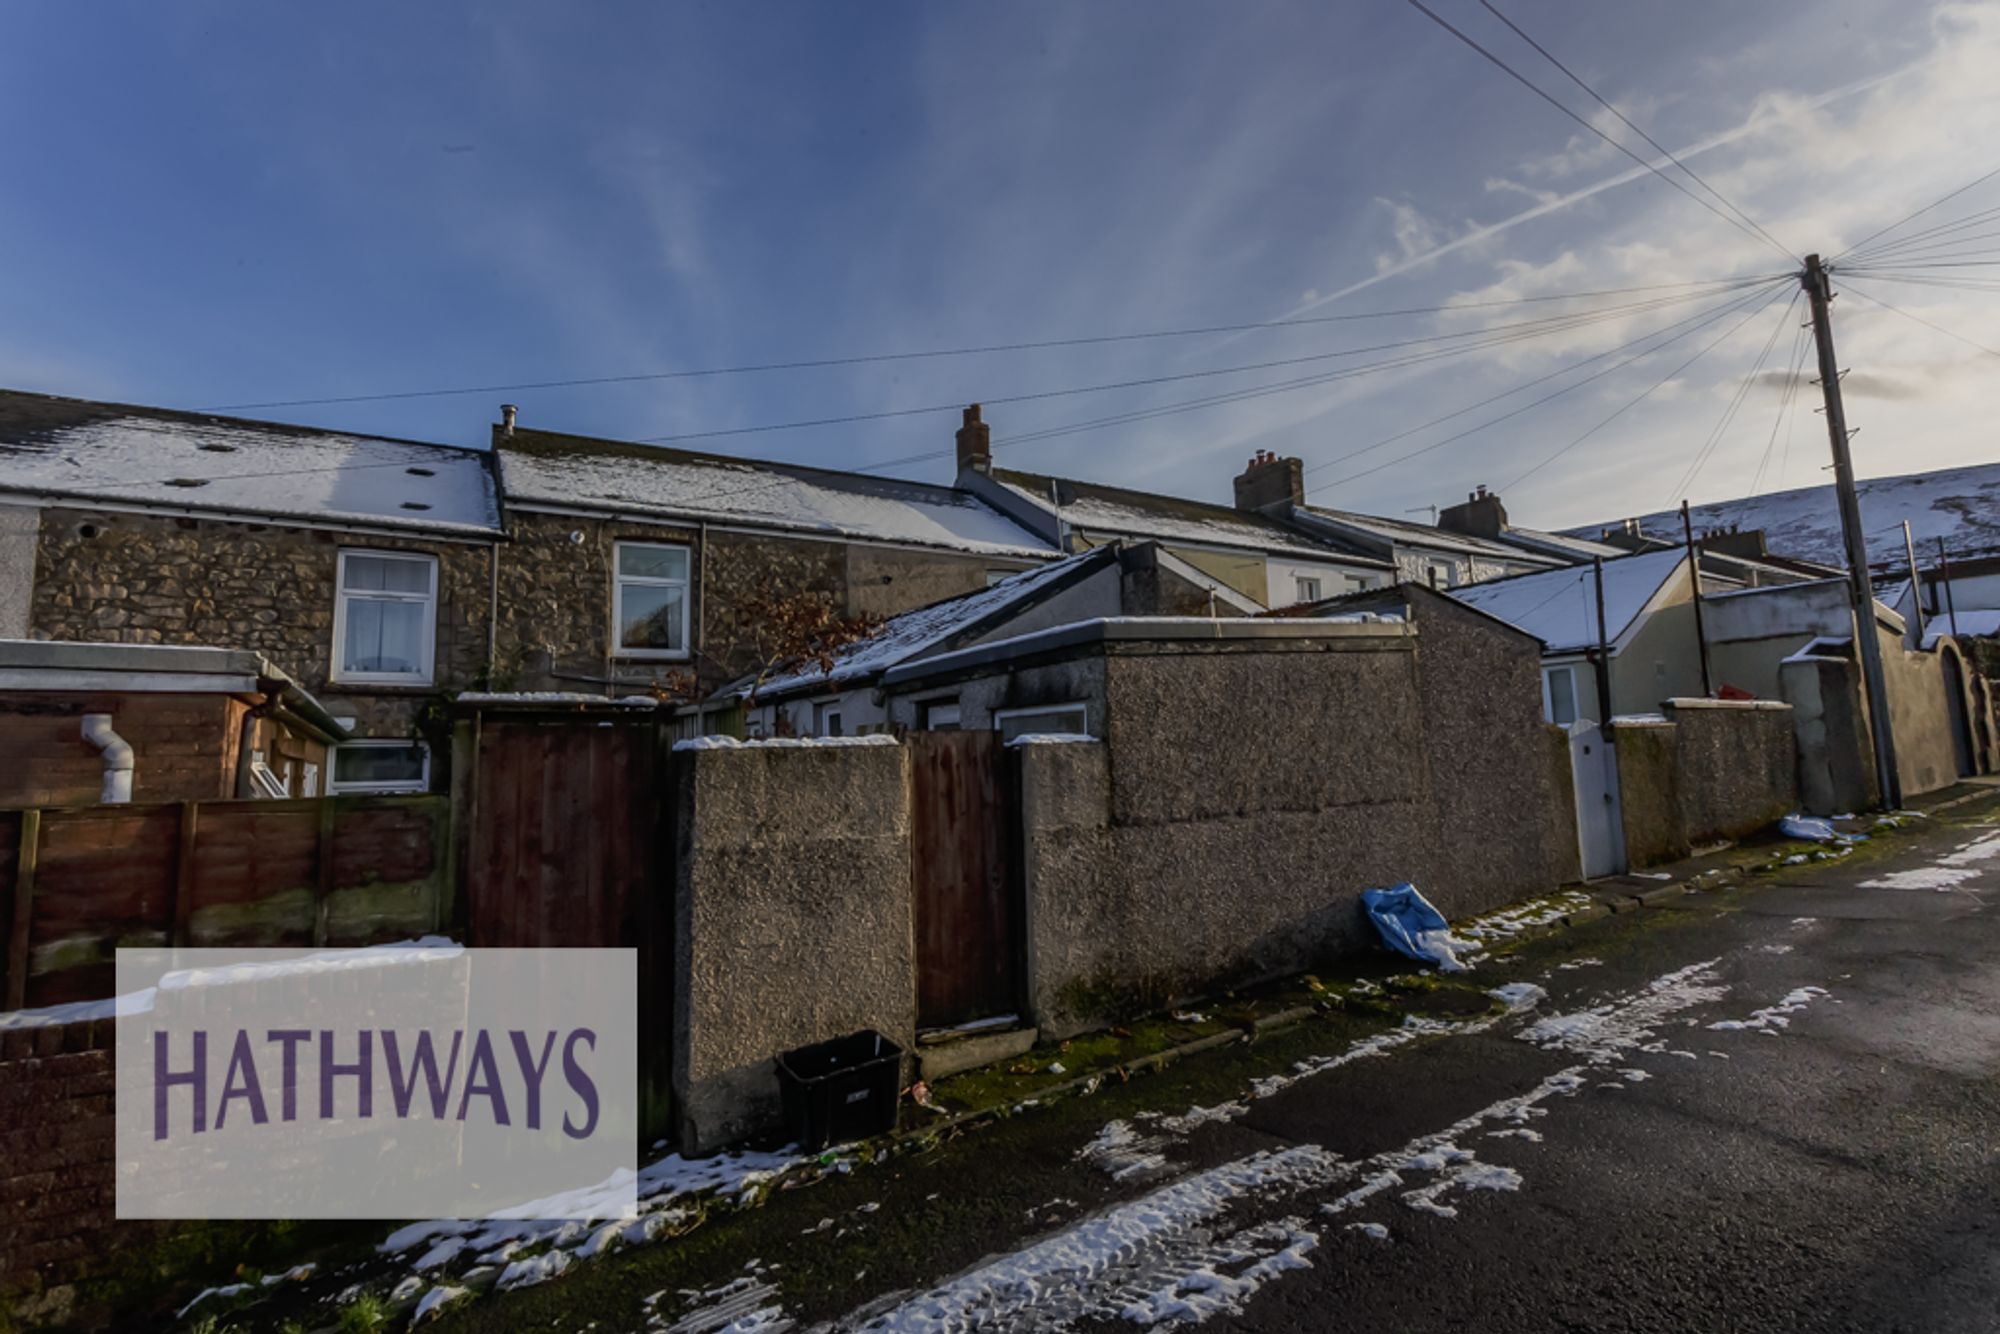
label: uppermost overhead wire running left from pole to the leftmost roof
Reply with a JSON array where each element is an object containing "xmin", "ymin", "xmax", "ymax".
[{"xmin": 198, "ymin": 278, "xmax": 1784, "ymax": 412}]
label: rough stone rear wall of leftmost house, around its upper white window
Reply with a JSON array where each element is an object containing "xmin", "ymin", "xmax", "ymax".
[{"xmin": 30, "ymin": 508, "xmax": 490, "ymax": 740}]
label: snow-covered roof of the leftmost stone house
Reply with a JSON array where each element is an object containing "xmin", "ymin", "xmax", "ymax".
[{"xmin": 0, "ymin": 390, "xmax": 500, "ymax": 534}]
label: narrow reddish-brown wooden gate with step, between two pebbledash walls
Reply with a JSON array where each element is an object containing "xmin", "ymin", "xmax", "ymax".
[{"xmin": 908, "ymin": 732, "xmax": 1022, "ymax": 1028}]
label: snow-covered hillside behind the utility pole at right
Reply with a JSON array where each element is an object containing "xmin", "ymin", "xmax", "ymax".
[{"xmin": 1568, "ymin": 464, "xmax": 2000, "ymax": 568}]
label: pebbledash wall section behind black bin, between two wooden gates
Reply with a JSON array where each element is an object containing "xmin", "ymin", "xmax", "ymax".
[{"xmin": 672, "ymin": 740, "xmax": 916, "ymax": 1154}]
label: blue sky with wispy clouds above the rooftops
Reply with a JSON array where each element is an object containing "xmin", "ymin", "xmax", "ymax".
[{"xmin": 0, "ymin": 0, "xmax": 2000, "ymax": 528}]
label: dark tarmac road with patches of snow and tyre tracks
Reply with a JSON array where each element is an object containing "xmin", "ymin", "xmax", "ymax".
[{"xmin": 444, "ymin": 796, "xmax": 2000, "ymax": 1334}]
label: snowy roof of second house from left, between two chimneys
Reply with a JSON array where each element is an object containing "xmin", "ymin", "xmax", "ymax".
[{"xmin": 498, "ymin": 430, "xmax": 1054, "ymax": 556}]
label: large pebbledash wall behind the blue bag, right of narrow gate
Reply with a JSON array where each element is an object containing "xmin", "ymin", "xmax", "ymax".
[{"xmin": 1020, "ymin": 614, "xmax": 1578, "ymax": 1036}]
